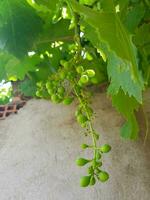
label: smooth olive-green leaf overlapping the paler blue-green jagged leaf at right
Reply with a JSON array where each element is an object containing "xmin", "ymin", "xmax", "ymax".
[{"xmin": 71, "ymin": 0, "xmax": 143, "ymax": 81}]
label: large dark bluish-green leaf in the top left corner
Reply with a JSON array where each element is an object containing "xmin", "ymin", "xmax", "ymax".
[{"xmin": 0, "ymin": 0, "xmax": 43, "ymax": 57}]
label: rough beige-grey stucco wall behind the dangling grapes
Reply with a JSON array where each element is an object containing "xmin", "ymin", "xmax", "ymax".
[{"xmin": 0, "ymin": 94, "xmax": 150, "ymax": 200}]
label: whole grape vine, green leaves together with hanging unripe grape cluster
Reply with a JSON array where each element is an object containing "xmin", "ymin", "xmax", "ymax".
[{"xmin": 0, "ymin": 0, "xmax": 150, "ymax": 187}]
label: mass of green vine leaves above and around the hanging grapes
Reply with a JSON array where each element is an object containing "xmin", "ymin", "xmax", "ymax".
[{"xmin": 0, "ymin": 0, "xmax": 150, "ymax": 139}]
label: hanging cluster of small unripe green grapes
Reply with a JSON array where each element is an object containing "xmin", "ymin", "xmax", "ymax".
[{"xmin": 37, "ymin": 60, "xmax": 111, "ymax": 187}]
